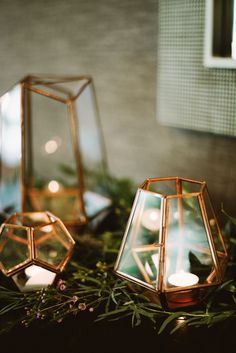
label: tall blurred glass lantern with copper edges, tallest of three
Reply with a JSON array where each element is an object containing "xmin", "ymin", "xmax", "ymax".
[{"xmin": 0, "ymin": 76, "xmax": 111, "ymax": 224}]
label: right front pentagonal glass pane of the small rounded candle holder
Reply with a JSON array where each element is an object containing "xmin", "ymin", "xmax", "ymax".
[{"xmin": 34, "ymin": 221, "xmax": 70, "ymax": 267}]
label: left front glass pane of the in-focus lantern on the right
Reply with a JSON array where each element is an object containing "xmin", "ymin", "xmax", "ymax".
[{"xmin": 118, "ymin": 190, "xmax": 162, "ymax": 288}]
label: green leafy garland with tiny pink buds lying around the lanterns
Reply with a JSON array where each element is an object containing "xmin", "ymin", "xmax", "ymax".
[{"xmin": 0, "ymin": 179, "xmax": 236, "ymax": 333}]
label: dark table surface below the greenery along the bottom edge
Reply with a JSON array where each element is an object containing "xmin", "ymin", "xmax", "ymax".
[{"xmin": 0, "ymin": 312, "xmax": 236, "ymax": 353}]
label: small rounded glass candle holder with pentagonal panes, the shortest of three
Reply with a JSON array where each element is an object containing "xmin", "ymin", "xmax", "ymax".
[{"xmin": 0, "ymin": 212, "xmax": 74, "ymax": 292}]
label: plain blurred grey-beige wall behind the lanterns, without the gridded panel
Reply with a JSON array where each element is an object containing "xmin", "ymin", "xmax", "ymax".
[{"xmin": 0, "ymin": 0, "xmax": 236, "ymax": 219}]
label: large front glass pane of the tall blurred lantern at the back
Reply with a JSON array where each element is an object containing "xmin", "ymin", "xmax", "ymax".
[{"xmin": 25, "ymin": 91, "xmax": 84, "ymax": 221}]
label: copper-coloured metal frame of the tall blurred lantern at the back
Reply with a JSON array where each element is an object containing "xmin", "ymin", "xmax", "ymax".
[{"xmin": 0, "ymin": 75, "xmax": 107, "ymax": 226}]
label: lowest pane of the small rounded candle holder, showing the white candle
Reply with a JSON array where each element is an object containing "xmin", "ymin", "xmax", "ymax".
[{"xmin": 12, "ymin": 265, "xmax": 56, "ymax": 292}]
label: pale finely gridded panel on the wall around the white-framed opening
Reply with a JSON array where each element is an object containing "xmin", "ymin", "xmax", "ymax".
[{"xmin": 157, "ymin": 0, "xmax": 236, "ymax": 136}]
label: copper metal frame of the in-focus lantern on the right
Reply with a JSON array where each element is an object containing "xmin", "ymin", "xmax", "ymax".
[{"xmin": 114, "ymin": 177, "xmax": 228, "ymax": 309}]
